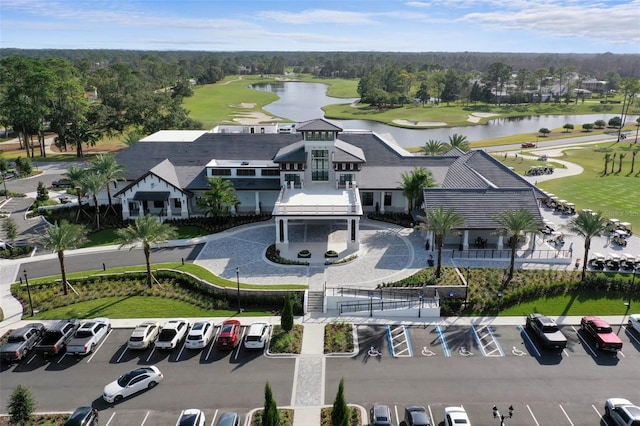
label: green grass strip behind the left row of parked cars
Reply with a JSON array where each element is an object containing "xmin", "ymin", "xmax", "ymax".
[{"xmin": 31, "ymin": 296, "xmax": 273, "ymax": 320}]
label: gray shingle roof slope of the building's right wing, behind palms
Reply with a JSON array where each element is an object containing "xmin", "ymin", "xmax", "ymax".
[{"xmin": 422, "ymin": 188, "xmax": 542, "ymax": 229}]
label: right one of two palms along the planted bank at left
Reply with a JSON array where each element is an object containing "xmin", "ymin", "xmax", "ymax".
[{"xmin": 116, "ymin": 215, "xmax": 177, "ymax": 287}]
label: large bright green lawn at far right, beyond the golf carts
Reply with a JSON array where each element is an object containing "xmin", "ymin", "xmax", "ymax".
[{"xmin": 538, "ymin": 144, "xmax": 640, "ymax": 230}]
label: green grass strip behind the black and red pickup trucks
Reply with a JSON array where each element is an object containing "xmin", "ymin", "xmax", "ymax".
[{"xmin": 499, "ymin": 291, "xmax": 640, "ymax": 316}]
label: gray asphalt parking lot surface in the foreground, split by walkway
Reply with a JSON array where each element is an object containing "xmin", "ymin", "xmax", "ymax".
[{"xmin": 0, "ymin": 325, "xmax": 640, "ymax": 426}]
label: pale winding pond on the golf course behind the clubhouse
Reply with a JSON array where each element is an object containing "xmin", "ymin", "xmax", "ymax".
[{"xmin": 251, "ymin": 82, "xmax": 637, "ymax": 148}]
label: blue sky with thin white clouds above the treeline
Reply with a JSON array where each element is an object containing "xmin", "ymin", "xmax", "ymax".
[{"xmin": 0, "ymin": 0, "xmax": 640, "ymax": 54}]
